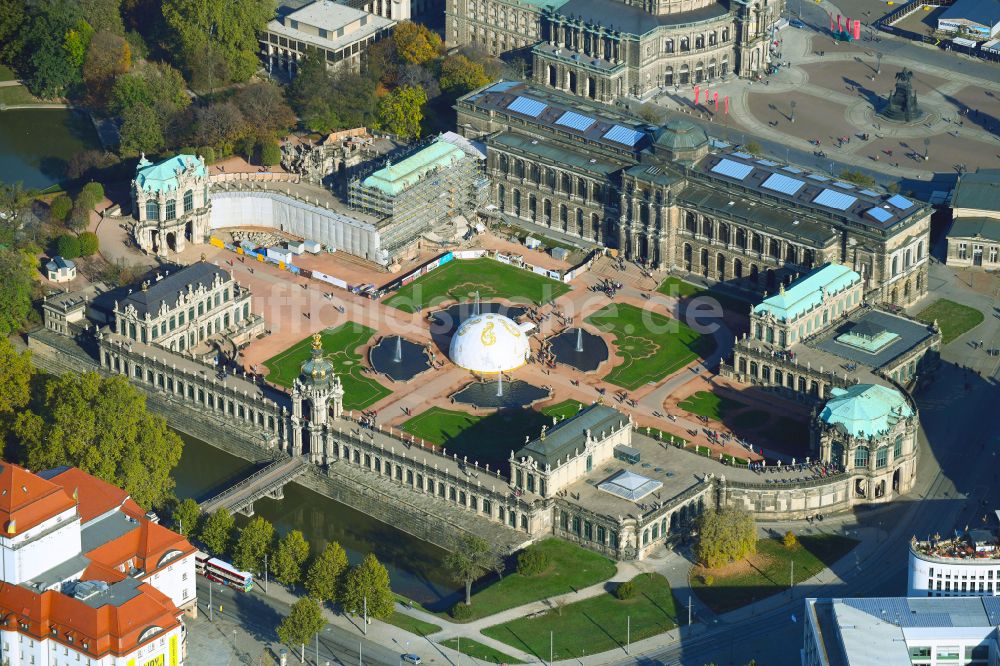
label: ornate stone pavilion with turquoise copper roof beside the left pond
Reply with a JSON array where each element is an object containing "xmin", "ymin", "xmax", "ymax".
[{"xmin": 132, "ymin": 155, "xmax": 211, "ymax": 256}]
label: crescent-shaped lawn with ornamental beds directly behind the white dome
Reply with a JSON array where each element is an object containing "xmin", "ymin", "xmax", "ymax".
[{"xmin": 384, "ymin": 258, "xmax": 569, "ymax": 312}]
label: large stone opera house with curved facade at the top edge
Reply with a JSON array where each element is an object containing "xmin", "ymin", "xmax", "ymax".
[{"xmin": 445, "ymin": 0, "xmax": 783, "ymax": 102}]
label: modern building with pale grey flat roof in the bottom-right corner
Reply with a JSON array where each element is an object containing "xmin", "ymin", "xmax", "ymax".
[{"xmin": 801, "ymin": 597, "xmax": 1000, "ymax": 666}]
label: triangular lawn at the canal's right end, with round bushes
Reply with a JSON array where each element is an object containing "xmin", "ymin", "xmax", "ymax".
[{"xmin": 446, "ymin": 539, "xmax": 617, "ymax": 620}]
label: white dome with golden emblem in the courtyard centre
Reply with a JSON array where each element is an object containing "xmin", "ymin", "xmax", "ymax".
[{"xmin": 448, "ymin": 313, "xmax": 534, "ymax": 375}]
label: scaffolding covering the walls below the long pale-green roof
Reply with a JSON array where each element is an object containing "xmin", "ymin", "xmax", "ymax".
[{"xmin": 348, "ymin": 142, "xmax": 489, "ymax": 255}]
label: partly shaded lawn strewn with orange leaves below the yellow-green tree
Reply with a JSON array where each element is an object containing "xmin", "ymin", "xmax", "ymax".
[{"xmin": 691, "ymin": 534, "xmax": 858, "ymax": 613}]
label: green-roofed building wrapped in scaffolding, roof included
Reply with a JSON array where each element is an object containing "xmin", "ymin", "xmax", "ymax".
[{"xmin": 348, "ymin": 133, "xmax": 489, "ymax": 256}]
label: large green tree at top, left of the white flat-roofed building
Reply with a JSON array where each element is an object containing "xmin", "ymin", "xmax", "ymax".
[{"xmin": 163, "ymin": 0, "xmax": 276, "ymax": 81}]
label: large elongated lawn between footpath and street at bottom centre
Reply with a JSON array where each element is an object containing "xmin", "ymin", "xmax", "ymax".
[{"xmin": 483, "ymin": 574, "xmax": 677, "ymax": 661}]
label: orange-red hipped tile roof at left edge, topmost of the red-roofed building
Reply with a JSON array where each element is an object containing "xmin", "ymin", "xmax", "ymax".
[{"xmin": 0, "ymin": 462, "xmax": 75, "ymax": 535}]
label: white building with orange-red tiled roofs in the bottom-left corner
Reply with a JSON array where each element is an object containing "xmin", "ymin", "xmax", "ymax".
[{"xmin": 0, "ymin": 462, "xmax": 196, "ymax": 666}]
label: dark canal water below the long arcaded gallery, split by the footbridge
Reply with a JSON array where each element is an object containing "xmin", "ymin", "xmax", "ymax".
[{"xmin": 174, "ymin": 434, "xmax": 459, "ymax": 610}]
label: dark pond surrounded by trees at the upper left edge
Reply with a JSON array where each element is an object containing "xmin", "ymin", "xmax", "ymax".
[{"xmin": 0, "ymin": 109, "xmax": 101, "ymax": 189}]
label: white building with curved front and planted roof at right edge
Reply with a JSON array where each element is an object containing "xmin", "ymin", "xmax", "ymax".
[{"xmin": 906, "ymin": 529, "xmax": 1000, "ymax": 597}]
